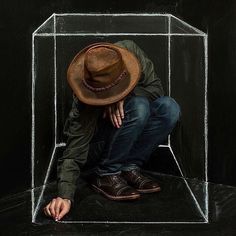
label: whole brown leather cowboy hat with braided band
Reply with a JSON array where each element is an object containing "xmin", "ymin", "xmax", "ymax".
[{"xmin": 67, "ymin": 43, "xmax": 141, "ymax": 105}]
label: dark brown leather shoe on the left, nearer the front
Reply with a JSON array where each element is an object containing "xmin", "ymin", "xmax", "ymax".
[{"xmin": 89, "ymin": 175, "xmax": 140, "ymax": 201}]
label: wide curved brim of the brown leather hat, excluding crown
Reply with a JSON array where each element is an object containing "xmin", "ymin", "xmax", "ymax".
[{"xmin": 67, "ymin": 43, "xmax": 141, "ymax": 106}]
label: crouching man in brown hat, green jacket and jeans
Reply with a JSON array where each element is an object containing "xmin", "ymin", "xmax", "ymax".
[{"xmin": 44, "ymin": 40, "xmax": 180, "ymax": 220}]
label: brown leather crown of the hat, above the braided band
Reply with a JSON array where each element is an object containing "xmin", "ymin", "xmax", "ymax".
[{"xmin": 84, "ymin": 46, "xmax": 125, "ymax": 89}]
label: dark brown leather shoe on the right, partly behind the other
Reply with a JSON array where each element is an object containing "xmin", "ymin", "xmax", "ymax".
[{"xmin": 121, "ymin": 169, "xmax": 161, "ymax": 193}]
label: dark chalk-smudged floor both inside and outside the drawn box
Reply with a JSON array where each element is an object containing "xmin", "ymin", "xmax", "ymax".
[{"xmin": 0, "ymin": 172, "xmax": 236, "ymax": 236}]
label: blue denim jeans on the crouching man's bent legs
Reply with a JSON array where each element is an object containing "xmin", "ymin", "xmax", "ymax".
[{"xmin": 85, "ymin": 96, "xmax": 180, "ymax": 176}]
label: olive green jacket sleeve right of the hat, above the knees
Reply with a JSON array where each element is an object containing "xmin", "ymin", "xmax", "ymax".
[{"xmin": 116, "ymin": 40, "xmax": 164, "ymax": 101}]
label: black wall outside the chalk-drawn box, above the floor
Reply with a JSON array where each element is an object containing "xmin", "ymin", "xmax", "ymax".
[{"xmin": 0, "ymin": 0, "xmax": 236, "ymax": 197}]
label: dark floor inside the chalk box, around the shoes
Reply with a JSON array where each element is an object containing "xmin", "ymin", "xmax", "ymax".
[{"xmin": 36, "ymin": 173, "xmax": 205, "ymax": 224}]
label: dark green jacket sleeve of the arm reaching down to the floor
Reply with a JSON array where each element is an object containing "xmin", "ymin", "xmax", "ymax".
[{"xmin": 57, "ymin": 97, "xmax": 99, "ymax": 202}]
